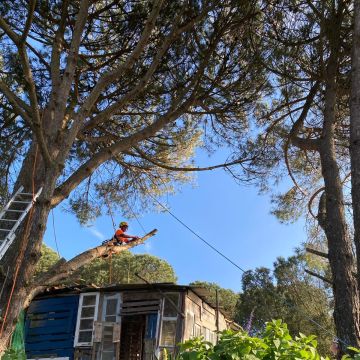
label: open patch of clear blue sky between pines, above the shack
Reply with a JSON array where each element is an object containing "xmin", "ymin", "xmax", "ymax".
[{"xmin": 45, "ymin": 160, "xmax": 306, "ymax": 291}]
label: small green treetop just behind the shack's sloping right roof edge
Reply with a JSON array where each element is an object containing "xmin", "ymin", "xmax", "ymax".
[{"xmin": 189, "ymin": 281, "xmax": 239, "ymax": 319}]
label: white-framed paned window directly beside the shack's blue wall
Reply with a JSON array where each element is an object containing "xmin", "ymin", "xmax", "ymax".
[{"xmin": 74, "ymin": 293, "xmax": 99, "ymax": 346}]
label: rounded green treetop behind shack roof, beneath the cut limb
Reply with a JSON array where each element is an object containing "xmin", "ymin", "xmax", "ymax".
[{"xmin": 72, "ymin": 251, "xmax": 177, "ymax": 286}]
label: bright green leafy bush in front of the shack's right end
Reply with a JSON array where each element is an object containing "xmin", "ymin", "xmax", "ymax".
[{"xmin": 177, "ymin": 320, "xmax": 360, "ymax": 360}]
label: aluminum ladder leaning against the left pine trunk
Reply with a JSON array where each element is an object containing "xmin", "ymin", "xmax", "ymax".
[{"xmin": 0, "ymin": 186, "xmax": 42, "ymax": 260}]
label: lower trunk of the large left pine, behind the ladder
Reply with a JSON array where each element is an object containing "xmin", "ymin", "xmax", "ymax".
[{"xmin": 0, "ymin": 145, "xmax": 57, "ymax": 353}]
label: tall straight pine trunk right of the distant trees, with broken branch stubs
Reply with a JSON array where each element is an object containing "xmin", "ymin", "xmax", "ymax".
[{"xmin": 318, "ymin": 17, "xmax": 360, "ymax": 352}]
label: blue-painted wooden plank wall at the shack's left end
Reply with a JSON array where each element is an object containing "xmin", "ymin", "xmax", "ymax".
[{"xmin": 25, "ymin": 295, "xmax": 79, "ymax": 359}]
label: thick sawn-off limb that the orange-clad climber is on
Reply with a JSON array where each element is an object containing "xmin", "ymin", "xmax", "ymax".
[{"xmin": 25, "ymin": 229, "xmax": 157, "ymax": 305}]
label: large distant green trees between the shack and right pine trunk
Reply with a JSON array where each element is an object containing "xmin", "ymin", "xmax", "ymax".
[{"xmin": 235, "ymin": 254, "xmax": 334, "ymax": 353}]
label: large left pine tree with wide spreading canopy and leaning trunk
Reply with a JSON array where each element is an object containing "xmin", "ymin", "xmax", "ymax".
[{"xmin": 0, "ymin": 0, "xmax": 267, "ymax": 351}]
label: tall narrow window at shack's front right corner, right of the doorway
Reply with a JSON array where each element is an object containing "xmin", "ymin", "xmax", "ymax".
[{"xmin": 160, "ymin": 293, "xmax": 180, "ymax": 348}]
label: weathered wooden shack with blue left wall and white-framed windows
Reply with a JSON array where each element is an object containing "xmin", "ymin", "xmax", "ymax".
[{"xmin": 25, "ymin": 284, "xmax": 239, "ymax": 360}]
